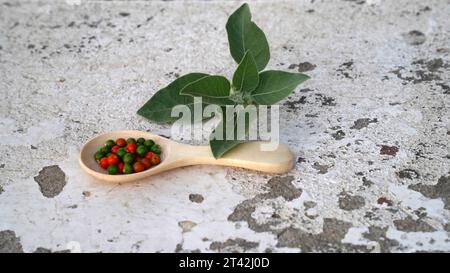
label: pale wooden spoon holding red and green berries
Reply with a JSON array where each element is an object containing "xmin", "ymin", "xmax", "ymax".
[{"xmin": 80, "ymin": 131, "xmax": 294, "ymax": 182}]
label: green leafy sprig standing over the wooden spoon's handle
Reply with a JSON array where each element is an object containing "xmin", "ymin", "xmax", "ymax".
[{"xmin": 137, "ymin": 4, "xmax": 309, "ymax": 158}]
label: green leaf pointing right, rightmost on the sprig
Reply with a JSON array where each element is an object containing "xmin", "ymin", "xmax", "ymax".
[{"xmin": 251, "ymin": 70, "xmax": 309, "ymax": 105}]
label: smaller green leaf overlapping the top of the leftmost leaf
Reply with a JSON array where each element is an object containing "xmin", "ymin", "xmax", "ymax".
[{"xmin": 180, "ymin": 76, "xmax": 234, "ymax": 105}]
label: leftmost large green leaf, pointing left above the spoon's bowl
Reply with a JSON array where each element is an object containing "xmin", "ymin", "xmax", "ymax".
[{"xmin": 137, "ymin": 73, "xmax": 208, "ymax": 123}]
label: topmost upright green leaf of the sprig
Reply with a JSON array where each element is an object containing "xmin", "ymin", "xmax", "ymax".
[{"xmin": 226, "ymin": 4, "xmax": 270, "ymax": 71}]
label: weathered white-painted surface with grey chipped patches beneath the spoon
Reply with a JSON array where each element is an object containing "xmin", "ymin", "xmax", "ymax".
[{"xmin": 0, "ymin": 0, "xmax": 450, "ymax": 252}]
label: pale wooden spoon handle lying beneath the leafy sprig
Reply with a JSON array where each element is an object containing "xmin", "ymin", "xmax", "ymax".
[{"xmin": 167, "ymin": 141, "xmax": 294, "ymax": 173}]
